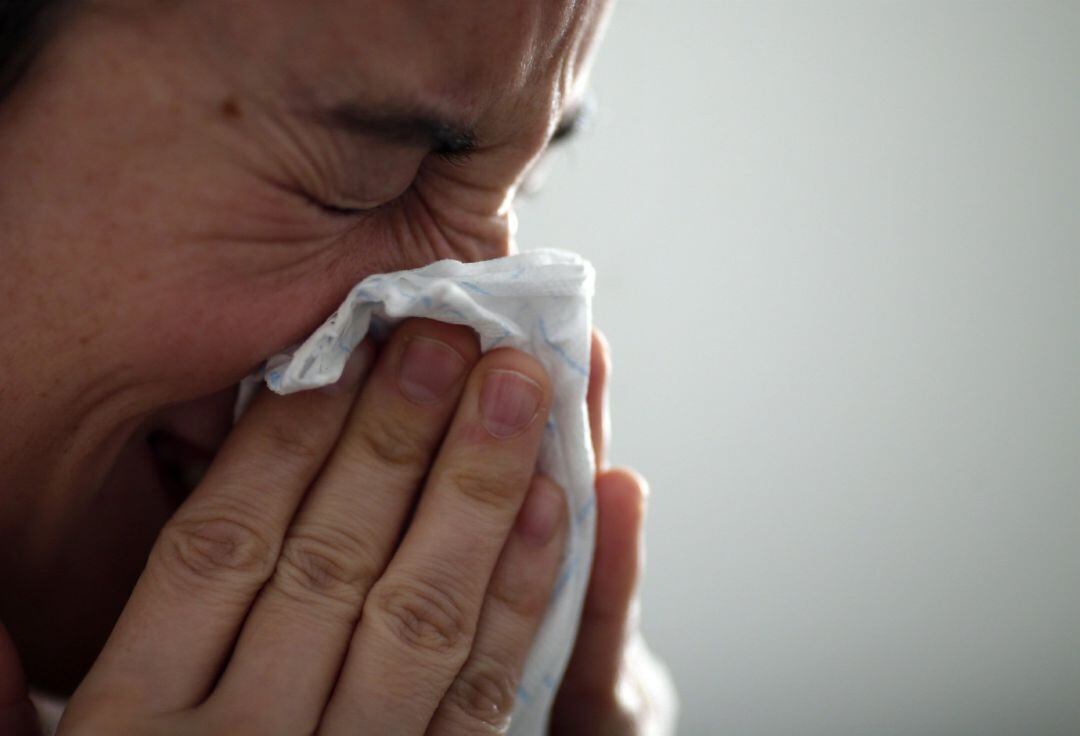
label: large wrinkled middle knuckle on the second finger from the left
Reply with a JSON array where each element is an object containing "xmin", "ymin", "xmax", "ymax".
[{"xmin": 276, "ymin": 527, "xmax": 378, "ymax": 610}]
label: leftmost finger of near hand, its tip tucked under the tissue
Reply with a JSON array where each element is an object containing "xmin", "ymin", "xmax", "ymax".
[{"xmin": 69, "ymin": 345, "xmax": 373, "ymax": 712}]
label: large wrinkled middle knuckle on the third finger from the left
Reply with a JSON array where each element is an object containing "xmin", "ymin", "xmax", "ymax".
[{"xmin": 365, "ymin": 580, "xmax": 473, "ymax": 658}]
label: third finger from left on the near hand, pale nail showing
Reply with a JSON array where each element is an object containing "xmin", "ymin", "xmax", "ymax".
[{"xmin": 324, "ymin": 350, "xmax": 551, "ymax": 734}]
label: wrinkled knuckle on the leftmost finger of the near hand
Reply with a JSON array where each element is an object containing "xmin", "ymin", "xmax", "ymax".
[{"xmin": 154, "ymin": 512, "xmax": 276, "ymax": 587}]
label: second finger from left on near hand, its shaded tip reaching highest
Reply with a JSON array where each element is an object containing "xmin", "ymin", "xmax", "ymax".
[{"xmin": 207, "ymin": 320, "xmax": 480, "ymax": 733}]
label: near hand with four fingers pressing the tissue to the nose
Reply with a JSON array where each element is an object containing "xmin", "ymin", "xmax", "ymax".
[{"xmin": 60, "ymin": 320, "xmax": 566, "ymax": 734}]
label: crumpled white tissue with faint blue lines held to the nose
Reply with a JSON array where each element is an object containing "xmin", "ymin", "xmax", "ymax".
[{"xmin": 238, "ymin": 251, "xmax": 595, "ymax": 735}]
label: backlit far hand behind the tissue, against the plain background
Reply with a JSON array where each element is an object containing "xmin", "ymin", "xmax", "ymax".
[{"xmin": 551, "ymin": 333, "xmax": 676, "ymax": 736}]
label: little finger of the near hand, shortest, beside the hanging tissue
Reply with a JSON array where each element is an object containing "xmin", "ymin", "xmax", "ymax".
[{"xmin": 428, "ymin": 476, "xmax": 567, "ymax": 736}]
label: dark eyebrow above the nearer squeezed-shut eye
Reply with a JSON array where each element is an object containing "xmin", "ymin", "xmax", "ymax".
[{"xmin": 315, "ymin": 103, "xmax": 476, "ymax": 155}]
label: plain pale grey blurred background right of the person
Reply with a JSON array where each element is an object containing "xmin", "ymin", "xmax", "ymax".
[{"xmin": 519, "ymin": 0, "xmax": 1080, "ymax": 736}]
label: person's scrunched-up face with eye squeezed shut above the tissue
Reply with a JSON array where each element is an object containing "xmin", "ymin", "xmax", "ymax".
[{"xmin": 0, "ymin": 0, "xmax": 608, "ymax": 687}]
